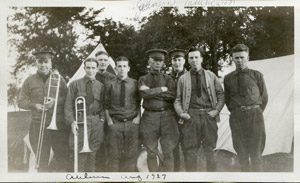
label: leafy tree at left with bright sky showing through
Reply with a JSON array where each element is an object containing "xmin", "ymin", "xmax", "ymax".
[{"xmin": 8, "ymin": 7, "xmax": 101, "ymax": 76}]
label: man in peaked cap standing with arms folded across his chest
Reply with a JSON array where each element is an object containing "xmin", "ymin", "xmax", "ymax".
[{"xmin": 138, "ymin": 49, "xmax": 179, "ymax": 172}]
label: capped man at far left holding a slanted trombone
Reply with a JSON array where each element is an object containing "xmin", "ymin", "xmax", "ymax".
[{"xmin": 18, "ymin": 50, "xmax": 69, "ymax": 172}]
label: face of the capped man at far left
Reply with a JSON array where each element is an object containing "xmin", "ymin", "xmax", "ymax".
[{"xmin": 36, "ymin": 53, "xmax": 52, "ymax": 75}]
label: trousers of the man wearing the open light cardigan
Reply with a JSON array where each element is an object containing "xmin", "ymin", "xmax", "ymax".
[{"xmin": 182, "ymin": 109, "xmax": 218, "ymax": 172}]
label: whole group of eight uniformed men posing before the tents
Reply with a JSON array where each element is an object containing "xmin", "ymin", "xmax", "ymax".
[{"xmin": 19, "ymin": 44, "xmax": 268, "ymax": 172}]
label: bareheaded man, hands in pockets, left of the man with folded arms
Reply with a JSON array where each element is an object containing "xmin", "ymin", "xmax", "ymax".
[{"xmin": 105, "ymin": 56, "xmax": 140, "ymax": 172}]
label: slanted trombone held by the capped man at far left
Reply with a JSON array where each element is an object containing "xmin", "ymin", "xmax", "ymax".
[{"xmin": 35, "ymin": 71, "xmax": 61, "ymax": 169}]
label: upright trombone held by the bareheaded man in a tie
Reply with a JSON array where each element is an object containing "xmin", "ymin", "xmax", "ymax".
[{"xmin": 74, "ymin": 97, "xmax": 93, "ymax": 172}]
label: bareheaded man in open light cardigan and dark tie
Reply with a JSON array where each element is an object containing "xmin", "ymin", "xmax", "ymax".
[{"xmin": 174, "ymin": 48, "xmax": 225, "ymax": 171}]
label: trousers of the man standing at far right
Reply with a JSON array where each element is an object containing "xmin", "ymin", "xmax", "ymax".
[{"xmin": 229, "ymin": 108, "xmax": 266, "ymax": 172}]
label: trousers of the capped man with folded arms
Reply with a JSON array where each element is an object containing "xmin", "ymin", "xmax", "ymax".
[{"xmin": 141, "ymin": 110, "xmax": 179, "ymax": 172}]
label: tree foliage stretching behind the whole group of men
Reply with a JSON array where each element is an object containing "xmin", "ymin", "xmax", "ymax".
[{"xmin": 7, "ymin": 7, "xmax": 294, "ymax": 110}]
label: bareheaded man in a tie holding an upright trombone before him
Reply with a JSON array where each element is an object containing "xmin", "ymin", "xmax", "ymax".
[{"xmin": 65, "ymin": 58, "xmax": 104, "ymax": 172}]
